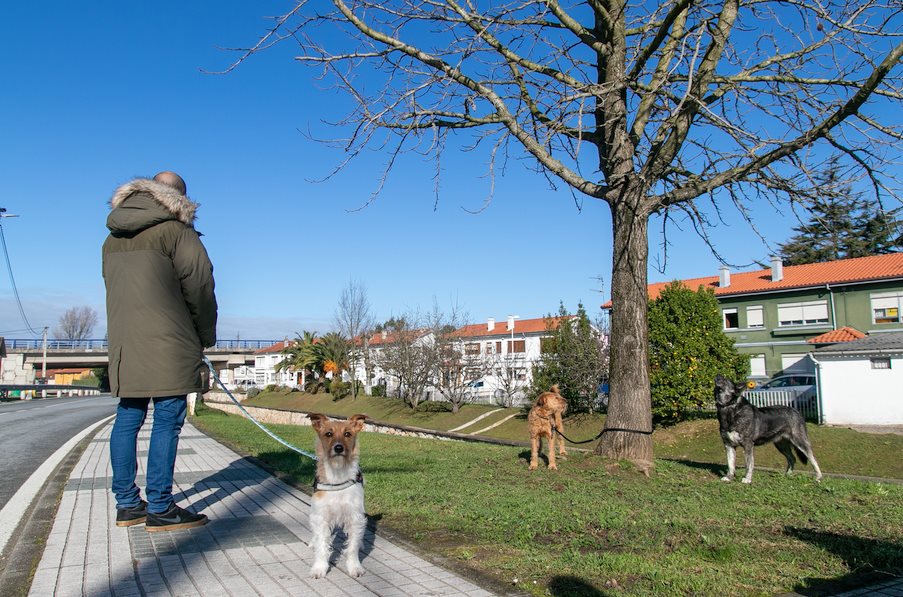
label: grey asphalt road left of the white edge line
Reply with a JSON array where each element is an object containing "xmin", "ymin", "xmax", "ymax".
[{"xmin": 0, "ymin": 394, "xmax": 117, "ymax": 509}]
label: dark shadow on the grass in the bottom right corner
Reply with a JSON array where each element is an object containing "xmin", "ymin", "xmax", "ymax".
[{"xmin": 784, "ymin": 527, "xmax": 903, "ymax": 595}]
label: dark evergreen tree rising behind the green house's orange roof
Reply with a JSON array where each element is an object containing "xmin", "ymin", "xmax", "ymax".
[{"xmin": 780, "ymin": 160, "xmax": 903, "ymax": 265}]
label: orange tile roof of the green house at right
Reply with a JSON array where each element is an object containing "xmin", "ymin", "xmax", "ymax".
[{"xmin": 602, "ymin": 253, "xmax": 903, "ymax": 309}]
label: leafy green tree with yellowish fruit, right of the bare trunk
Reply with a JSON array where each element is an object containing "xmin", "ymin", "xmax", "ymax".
[{"xmin": 649, "ymin": 282, "xmax": 749, "ymax": 423}]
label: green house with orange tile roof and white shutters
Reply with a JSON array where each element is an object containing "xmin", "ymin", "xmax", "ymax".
[{"xmin": 616, "ymin": 253, "xmax": 903, "ymax": 379}]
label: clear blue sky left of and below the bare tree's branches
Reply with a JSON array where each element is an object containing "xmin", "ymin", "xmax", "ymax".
[{"xmin": 0, "ymin": 0, "xmax": 888, "ymax": 339}]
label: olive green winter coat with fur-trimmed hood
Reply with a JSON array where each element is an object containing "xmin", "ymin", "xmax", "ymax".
[{"xmin": 103, "ymin": 178, "xmax": 216, "ymax": 398}]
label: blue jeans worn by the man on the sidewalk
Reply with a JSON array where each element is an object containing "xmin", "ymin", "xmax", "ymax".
[{"xmin": 110, "ymin": 396, "xmax": 187, "ymax": 514}]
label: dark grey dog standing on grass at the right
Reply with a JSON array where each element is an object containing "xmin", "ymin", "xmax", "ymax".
[{"xmin": 715, "ymin": 375, "xmax": 821, "ymax": 483}]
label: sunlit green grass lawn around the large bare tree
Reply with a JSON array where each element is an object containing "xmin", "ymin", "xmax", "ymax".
[{"xmin": 192, "ymin": 396, "xmax": 903, "ymax": 595}]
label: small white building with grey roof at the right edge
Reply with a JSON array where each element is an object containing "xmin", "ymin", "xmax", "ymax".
[{"xmin": 810, "ymin": 332, "xmax": 903, "ymax": 425}]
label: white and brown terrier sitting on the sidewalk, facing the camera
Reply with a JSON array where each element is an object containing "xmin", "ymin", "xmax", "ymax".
[{"xmin": 307, "ymin": 414, "xmax": 367, "ymax": 578}]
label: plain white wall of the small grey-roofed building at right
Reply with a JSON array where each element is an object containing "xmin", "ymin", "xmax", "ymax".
[{"xmin": 818, "ymin": 356, "xmax": 903, "ymax": 425}]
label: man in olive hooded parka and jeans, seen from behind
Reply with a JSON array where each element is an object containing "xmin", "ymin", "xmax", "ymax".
[{"xmin": 103, "ymin": 172, "xmax": 216, "ymax": 531}]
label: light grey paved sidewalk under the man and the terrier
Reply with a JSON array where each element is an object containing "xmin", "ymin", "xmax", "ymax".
[{"xmin": 29, "ymin": 416, "xmax": 502, "ymax": 597}]
